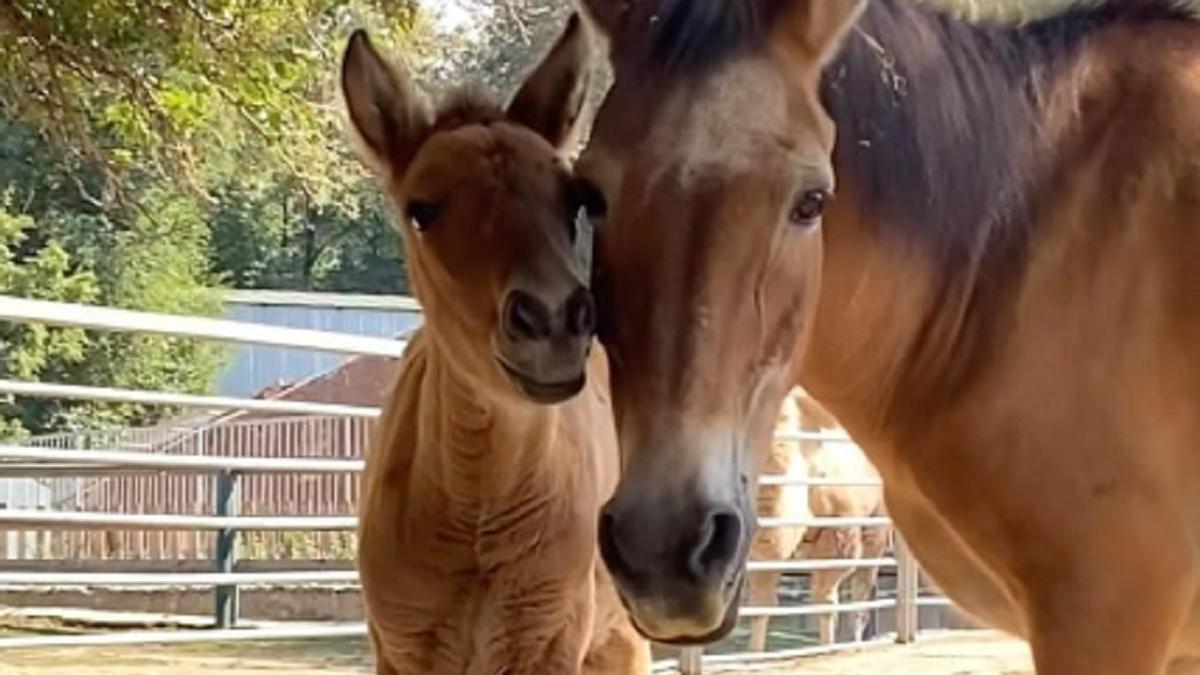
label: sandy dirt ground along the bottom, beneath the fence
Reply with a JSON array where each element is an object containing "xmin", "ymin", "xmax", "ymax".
[{"xmin": 0, "ymin": 631, "xmax": 1033, "ymax": 675}]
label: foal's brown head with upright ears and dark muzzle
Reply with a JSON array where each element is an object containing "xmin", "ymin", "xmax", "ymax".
[{"xmin": 342, "ymin": 18, "xmax": 595, "ymax": 402}]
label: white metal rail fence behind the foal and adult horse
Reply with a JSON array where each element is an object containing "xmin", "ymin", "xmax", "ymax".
[{"xmin": 0, "ymin": 297, "xmax": 948, "ymax": 673}]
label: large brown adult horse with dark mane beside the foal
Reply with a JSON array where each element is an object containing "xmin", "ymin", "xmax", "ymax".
[{"xmin": 577, "ymin": 0, "xmax": 1200, "ymax": 675}]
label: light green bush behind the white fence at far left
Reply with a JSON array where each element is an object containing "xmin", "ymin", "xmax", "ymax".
[{"xmin": 0, "ymin": 183, "xmax": 222, "ymax": 436}]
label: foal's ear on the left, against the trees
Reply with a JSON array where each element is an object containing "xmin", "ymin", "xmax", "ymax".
[{"xmin": 342, "ymin": 29, "xmax": 432, "ymax": 173}]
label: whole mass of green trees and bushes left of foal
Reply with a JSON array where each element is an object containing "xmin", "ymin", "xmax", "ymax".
[{"xmin": 0, "ymin": 0, "xmax": 432, "ymax": 432}]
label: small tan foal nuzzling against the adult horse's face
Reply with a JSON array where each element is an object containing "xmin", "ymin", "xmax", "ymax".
[{"xmin": 342, "ymin": 18, "xmax": 649, "ymax": 675}]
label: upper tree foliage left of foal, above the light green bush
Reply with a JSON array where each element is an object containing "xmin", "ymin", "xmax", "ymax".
[{"xmin": 0, "ymin": 0, "xmax": 432, "ymax": 292}]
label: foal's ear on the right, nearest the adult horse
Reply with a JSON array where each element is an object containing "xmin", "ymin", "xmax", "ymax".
[{"xmin": 506, "ymin": 13, "xmax": 592, "ymax": 150}]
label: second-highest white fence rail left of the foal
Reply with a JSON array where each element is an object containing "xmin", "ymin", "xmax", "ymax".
[{"xmin": 0, "ymin": 380, "xmax": 379, "ymax": 418}]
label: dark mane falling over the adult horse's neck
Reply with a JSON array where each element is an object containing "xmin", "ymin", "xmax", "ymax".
[{"xmin": 822, "ymin": 0, "xmax": 1183, "ymax": 258}]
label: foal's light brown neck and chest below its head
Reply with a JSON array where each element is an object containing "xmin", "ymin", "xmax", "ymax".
[{"xmin": 359, "ymin": 333, "xmax": 648, "ymax": 675}]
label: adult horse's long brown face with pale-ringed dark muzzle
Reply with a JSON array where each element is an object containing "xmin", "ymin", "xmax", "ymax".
[{"xmin": 577, "ymin": 0, "xmax": 864, "ymax": 643}]
